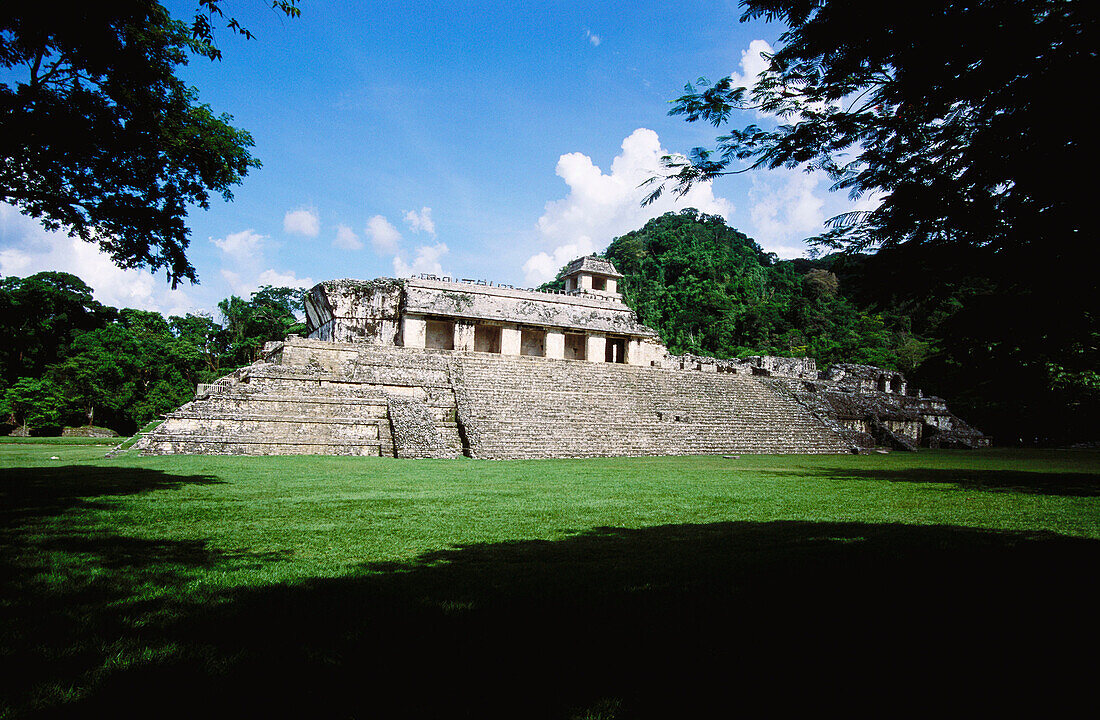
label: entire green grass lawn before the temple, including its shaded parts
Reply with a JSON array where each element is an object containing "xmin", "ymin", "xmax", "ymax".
[{"xmin": 0, "ymin": 442, "xmax": 1100, "ymax": 718}]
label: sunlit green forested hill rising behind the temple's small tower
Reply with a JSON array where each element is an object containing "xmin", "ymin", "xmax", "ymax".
[{"xmin": 551, "ymin": 209, "xmax": 928, "ymax": 372}]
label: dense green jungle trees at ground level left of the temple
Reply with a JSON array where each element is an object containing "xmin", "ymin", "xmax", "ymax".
[{"xmin": 0, "ymin": 273, "xmax": 304, "ymax": 434}]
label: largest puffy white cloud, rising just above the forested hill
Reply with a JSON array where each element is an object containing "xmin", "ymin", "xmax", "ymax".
[{"xmin": 524, "ymin": 128, "xmax": 734, "ymax": 286}]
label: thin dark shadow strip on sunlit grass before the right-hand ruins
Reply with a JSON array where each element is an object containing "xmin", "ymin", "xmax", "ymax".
[{"xmin": 767, "ymin": 467, "xmax": 1100, "ymax": 498}]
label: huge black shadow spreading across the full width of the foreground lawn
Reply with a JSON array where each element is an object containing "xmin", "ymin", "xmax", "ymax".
[{"xmin": 4, "ymin": 522, "xmax": 1100, "ymax": 718}]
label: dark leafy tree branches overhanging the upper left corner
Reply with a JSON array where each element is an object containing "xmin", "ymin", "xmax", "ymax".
[{"xmin": 0, "ymin": 0, "xmax": 298, "ymax": 287}]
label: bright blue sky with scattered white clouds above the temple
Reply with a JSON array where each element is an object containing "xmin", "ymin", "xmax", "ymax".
[{"xmin": 0, "ymin": 0, "xmax": 875, "ymax": 313}]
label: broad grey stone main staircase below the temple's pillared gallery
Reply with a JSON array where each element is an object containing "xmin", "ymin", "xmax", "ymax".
[{"xmin": 455, "ymin": 356, "xmax": 849, "ymax": 458}]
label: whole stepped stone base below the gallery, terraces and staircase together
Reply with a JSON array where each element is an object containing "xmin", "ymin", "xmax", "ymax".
[{"xmin": 134, "ymin": 339, "xmax": 849, "ymax": 458}]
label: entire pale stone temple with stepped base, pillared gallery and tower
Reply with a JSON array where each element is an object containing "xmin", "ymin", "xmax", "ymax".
[{"xmin": 135, "ymin": 257, "xmax": 989, "ymax": 458}]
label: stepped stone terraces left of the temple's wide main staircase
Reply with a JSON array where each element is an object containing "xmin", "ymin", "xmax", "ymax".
[{"xmin": 134, "ymin": 343, "xmax": 462, "ymax": 457}]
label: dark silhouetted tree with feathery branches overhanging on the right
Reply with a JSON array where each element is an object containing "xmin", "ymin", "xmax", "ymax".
[{"xmin": 647, "ymin": 0, "xmax": 1100, "ymax": 440}]
